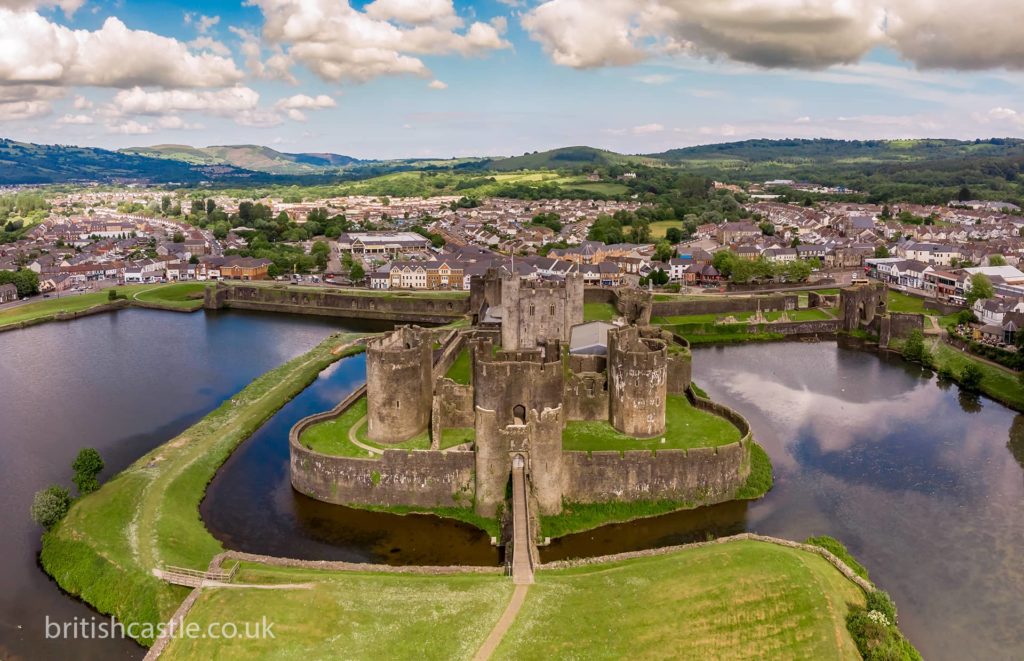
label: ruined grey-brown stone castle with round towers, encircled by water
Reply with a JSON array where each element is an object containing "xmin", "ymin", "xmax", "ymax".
[{"xmin": 291, "ymin": 272, "xmax": 750, "ymax": 517}]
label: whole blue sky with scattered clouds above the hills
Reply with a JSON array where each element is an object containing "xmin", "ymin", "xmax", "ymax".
[{"xmin": 0, "ymin": 0, "xmax": 1024, "ymax": 159}]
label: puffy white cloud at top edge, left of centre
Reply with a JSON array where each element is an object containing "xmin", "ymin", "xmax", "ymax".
[{"xmin": 244, "ymin": 0, "xmax": 511, "ymax": 82}]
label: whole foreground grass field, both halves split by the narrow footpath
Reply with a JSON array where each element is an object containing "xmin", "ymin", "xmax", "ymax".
[{"xmin": 155, "ymin": 540, "xmax": 864, "ymax": 661}]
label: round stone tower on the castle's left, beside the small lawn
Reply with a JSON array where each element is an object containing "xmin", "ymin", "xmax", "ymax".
[{"xmin": 367, "ymin": 326, "xmax": 433, "ymax": 443}]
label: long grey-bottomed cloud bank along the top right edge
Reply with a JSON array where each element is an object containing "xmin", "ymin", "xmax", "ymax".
[{"xmin": 522, "ymin": 0, "xmax": 1024, "ymax": 70}]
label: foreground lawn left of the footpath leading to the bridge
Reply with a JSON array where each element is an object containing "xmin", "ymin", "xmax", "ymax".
[{"xmin": 162, "ymin": 565, "xmax": 513, "ymax": 661}]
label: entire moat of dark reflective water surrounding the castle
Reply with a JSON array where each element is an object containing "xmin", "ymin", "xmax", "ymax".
[{"xmin": 0, "ymin": 310, "xmax": 1024, "ymax": 659}]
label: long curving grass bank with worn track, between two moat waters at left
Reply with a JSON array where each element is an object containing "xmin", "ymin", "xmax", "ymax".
[{"xmin": 40, "ymin": 334, "xmax": 361, "ymax": 644}]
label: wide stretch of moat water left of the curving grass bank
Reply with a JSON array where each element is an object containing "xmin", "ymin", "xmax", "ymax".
[{"xmin": 0, "ymin": 309, "xmax": 389, "ymax": 661}]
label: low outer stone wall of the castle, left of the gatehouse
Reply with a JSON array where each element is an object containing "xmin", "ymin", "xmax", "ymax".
[{"xmin": 291, "ymin": 443, "xmax": 475, "ymax": 508}]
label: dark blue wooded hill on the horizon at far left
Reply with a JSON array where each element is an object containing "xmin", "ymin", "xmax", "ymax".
[{"xmin": 0, "ymin": 138, "xmax": 257, "ymax": 184}]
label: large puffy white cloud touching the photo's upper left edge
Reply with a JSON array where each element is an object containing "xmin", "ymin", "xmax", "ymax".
[{"xmin": 0, "ymin": 9, "xmax": 242, "ymax": 88}]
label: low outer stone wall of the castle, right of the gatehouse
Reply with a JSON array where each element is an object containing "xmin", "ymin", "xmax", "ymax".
[{"xmin": 563, "ymin": 443, "xmax": 751, "ymax": 504}]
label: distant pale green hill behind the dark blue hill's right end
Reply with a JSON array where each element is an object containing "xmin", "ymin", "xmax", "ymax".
[{"xmin": 121, "ymin": 144, "xmax": 359, "ymax": 175}]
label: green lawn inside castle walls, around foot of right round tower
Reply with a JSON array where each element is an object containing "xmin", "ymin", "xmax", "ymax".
[{"xmin": 562, "ymin": 395, "xmax": 740, "ymax": 452}]
